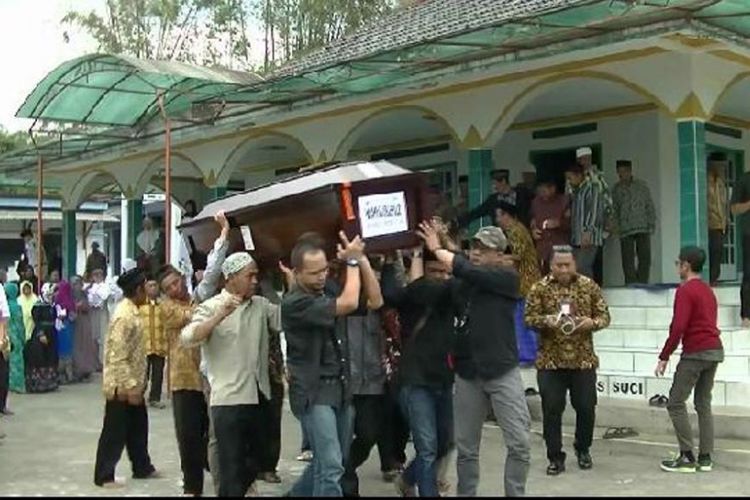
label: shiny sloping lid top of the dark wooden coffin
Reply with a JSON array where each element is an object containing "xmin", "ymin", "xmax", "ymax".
[{"xmin": 182, "ymin": 160, "xmax": 417, "ymax": 227}]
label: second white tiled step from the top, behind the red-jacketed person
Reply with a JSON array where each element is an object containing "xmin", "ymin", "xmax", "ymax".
[{"xmin": 609, "ymin": 304, "xmax": 742, "ymax": 329}]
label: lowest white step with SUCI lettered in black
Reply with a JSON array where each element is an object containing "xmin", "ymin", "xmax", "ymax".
[{"xmin": 521, "ymin": 368, "xmax": 750, "ymax": 406}]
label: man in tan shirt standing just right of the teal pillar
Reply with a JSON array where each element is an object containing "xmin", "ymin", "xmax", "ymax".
[{"xmin": 707, "ymin": 158, "xmax": 729, "ymax": 286}]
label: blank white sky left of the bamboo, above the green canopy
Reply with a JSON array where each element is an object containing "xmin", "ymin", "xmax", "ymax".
[{"xmin": 0, "ymin": 0, "xmax": 262, "ymax": 131}]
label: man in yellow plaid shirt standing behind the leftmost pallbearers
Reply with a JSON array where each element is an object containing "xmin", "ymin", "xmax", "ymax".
[{"xmin": 138, "ymin": 279, "xmax": 167, "ymax": 409}]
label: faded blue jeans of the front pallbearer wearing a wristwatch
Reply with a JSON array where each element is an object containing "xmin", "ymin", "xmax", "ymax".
[{"xmin": 289, "ymin": 404, "xmax": 354, "ymax": 497}]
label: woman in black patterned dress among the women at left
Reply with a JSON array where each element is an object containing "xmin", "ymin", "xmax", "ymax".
[{"xmin": 22, "ymin": 287, "xmax": 59, "ymax": 393}]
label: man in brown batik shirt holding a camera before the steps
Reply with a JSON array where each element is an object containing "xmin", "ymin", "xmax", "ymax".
[{"xmin": 525, "ymin": 246, "xmax": 610, "ymax": 476}]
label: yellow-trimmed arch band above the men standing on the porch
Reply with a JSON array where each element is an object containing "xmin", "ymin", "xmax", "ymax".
[{"xmin": 483, "ymin": 70, "xmax": 673, "ymax": 146}]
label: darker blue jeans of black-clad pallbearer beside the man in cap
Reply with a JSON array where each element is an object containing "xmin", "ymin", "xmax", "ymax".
[{"xmin": 401, "ymin": 385, "xmax": 453, "ymax": 497}]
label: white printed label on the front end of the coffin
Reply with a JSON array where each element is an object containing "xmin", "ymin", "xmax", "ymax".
[{"xmin": 357, "ymin": 191, "xmax": 409, "ymax": 238}]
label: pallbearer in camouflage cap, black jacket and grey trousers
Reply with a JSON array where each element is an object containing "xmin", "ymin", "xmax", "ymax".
[{"xmin": 420, "ymin": 223, "xmax": 530, "ymax": 496}]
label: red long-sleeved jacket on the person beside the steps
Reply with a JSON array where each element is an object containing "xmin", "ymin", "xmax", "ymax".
[{"xmin": 659, "ymin": 279, "xmax": 722, "ymax": 361}]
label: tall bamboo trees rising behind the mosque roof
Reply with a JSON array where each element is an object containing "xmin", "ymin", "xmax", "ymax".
[{"xmin": 62, "ymin": 0, "xmax": 403, "ymax": 71}]
